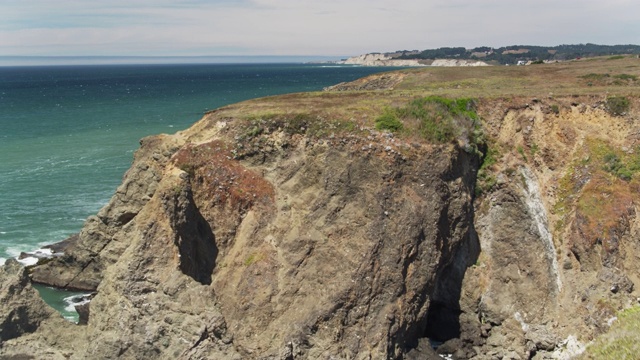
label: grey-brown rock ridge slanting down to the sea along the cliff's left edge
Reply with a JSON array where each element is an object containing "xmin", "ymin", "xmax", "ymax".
[{"xmin": 31, "ymin": 136, "xmax": 176, "ymax": 291}]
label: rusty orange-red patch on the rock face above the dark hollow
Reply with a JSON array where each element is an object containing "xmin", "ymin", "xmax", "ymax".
[{"xmin": 173, "ymin": 140, "xmax": 274, "ymax": 210}]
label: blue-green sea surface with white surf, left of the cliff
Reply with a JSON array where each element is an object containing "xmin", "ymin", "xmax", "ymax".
[{"xmin": 0, "ymin": 63, "xmax": 400, "ymax": 320}]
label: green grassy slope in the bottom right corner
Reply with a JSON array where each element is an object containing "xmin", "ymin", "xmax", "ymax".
[{"xmin": 583, "ymin": 306, "xmax": 640, "ymax": 360}]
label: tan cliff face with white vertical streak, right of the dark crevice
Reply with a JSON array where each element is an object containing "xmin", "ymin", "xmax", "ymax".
[{"xmin": 459, "ymin": 97, "xmax": 638, "ymax": 359}]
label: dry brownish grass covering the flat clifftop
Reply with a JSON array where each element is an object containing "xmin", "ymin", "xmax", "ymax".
[{"xmin": 191, "ymin": 57, "xmax": 640, "ymax": 150}]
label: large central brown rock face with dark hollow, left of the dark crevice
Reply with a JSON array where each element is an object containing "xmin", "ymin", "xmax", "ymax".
[{"xmin": 3, "ymin": 102, "xmax": 479, "ymax": 359}]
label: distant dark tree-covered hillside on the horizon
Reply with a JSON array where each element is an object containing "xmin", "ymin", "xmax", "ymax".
[{"xmin": 396, "ymin": 44, "xmax": 640, "ymax": 65}]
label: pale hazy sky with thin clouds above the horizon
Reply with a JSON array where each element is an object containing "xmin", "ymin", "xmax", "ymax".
[{"xmin": 0, "ymin": 0, "xmax": 640, "ymax": 57}]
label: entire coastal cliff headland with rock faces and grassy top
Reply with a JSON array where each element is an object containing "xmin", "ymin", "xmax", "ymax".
[{"xmin": 0, "ymin": 54, "xmax": 640, "ymax": 359}]
